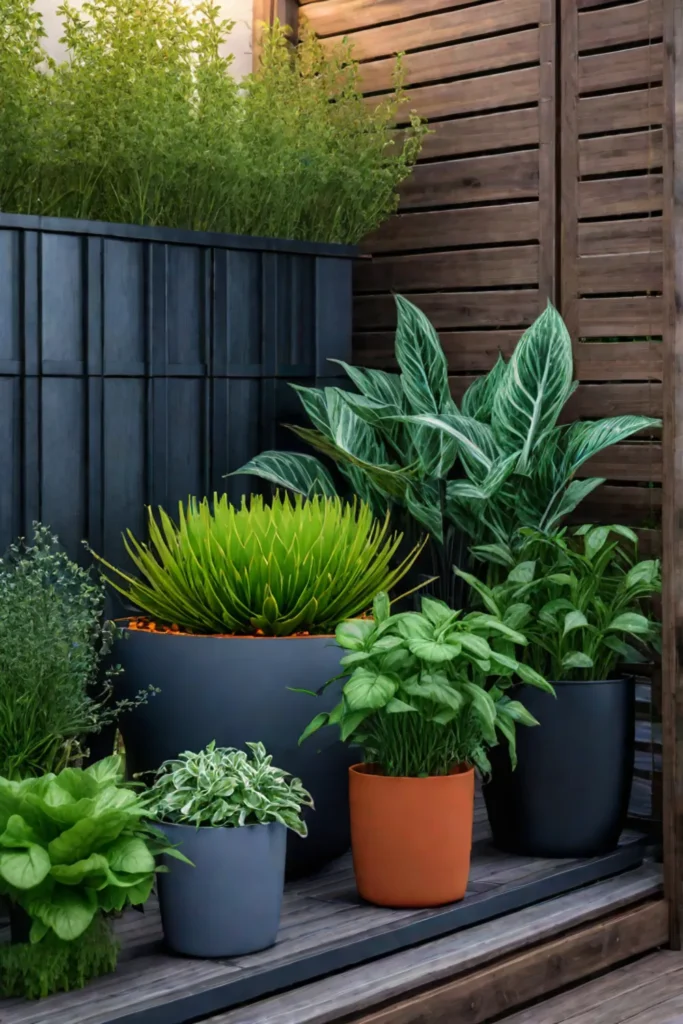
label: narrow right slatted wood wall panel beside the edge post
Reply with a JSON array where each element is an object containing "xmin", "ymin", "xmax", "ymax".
[{"xmin": 558, "ymin": 0, "xmax": 664, "ymax": 526}]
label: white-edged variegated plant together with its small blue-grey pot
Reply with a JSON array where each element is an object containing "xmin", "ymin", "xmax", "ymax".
[{"xmin": 152, "ymin": 741, "xmax": 313, "ymax": 956}]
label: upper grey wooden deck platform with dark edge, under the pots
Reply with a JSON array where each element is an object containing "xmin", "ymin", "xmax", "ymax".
[{"xmin": 0, "ymin": 835, "xmax": 652, "ymax": 1024}]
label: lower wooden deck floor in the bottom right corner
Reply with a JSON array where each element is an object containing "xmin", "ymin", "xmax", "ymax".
[{"xmin": 500, "ymin": 951, "xmax": 683, "ymax": 1024}]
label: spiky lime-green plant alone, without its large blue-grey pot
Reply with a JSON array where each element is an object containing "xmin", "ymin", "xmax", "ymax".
[{"xmin": 100, "ymin": 494, "xmax": 422, "ymax": 636}]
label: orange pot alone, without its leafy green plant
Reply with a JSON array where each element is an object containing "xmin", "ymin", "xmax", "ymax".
[{"xmin": 349, "ymin": 765, "xmax": 474, "ymax": 907}]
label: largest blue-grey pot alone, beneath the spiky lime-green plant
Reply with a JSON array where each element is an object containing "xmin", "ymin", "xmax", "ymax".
[{"xmin": 114, "ymin": 630, "xmax": 357, "ymax": 877}]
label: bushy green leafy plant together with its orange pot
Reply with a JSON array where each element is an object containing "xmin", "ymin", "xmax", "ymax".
[{"xmin": 301, "ymin": 594, "xmax": 550, "ymax": 907}]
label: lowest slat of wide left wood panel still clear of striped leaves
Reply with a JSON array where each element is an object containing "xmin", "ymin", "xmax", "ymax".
[{"xmin": 353, "ymin": 246, "xmax": 539, "ymax": 294}]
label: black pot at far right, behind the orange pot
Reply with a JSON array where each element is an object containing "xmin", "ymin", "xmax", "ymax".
[{"xmin": 483, "ymin": 679, "xmax": 635, "ymax": 857}]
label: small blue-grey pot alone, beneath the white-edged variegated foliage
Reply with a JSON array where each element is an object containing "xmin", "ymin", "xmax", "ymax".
[{"xmin": 159, "ymin": 821, "xmax": 287, "ymax": 956}]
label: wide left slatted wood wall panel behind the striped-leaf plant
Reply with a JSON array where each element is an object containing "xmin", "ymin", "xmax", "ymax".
[{"xmin": 300, "ymin": 0, "xmax": 556, "ymax": 391}]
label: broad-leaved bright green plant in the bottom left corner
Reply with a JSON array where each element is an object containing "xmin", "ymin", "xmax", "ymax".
[{"xmin": 0, "ymin": 756, "xmax": 180, "ymax": 998}]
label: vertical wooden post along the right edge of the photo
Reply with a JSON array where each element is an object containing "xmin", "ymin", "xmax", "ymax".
[{"xmin": 661, "ymin": 0, "xmax": 683, "ymax": 949}]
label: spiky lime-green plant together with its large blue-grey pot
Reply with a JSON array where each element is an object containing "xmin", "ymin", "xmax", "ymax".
[{"xmin": 96, "ymin": 495, "xmax": 418, "ymax": 872}]
